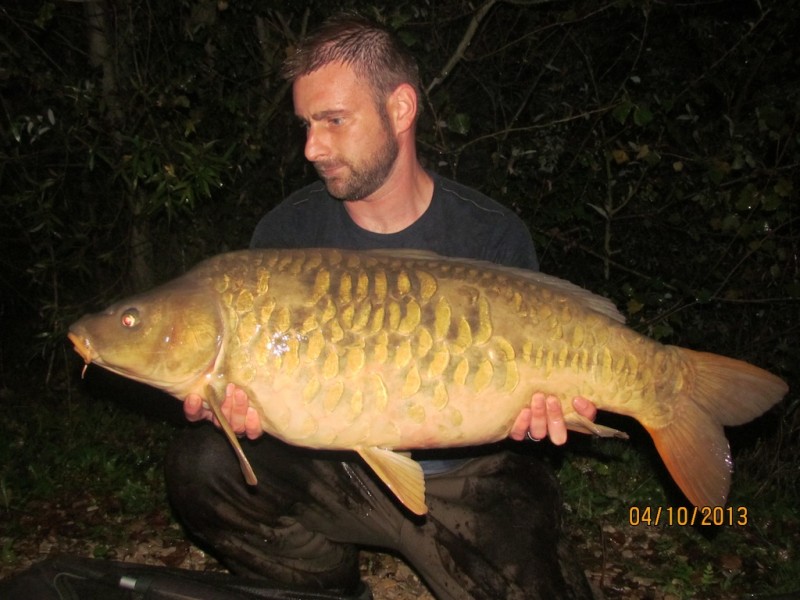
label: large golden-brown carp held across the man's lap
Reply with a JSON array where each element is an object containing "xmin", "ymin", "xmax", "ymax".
[{"xmin": 70, "ymin": 249, "xmax": 787, "ymax": 513}]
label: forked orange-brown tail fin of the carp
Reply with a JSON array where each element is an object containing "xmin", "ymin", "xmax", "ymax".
[{"xmin": 645, "ymin": 347, "xmax": 789, "ymax": 506}]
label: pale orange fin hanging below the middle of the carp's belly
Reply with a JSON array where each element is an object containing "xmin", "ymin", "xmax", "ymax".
[{"xmin": 355, "ymin": 446, "xmax": 428, "ymax": 515}]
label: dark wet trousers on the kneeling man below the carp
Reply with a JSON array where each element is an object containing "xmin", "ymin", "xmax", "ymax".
[{"xmin": 166, "ymin": 426, "xmax": 591, "ymax": 600}]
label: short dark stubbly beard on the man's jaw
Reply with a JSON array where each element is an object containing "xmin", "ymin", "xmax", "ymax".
[{"xmin": 314, "ymin": 117, "xmax": 398, "ymax": 200}]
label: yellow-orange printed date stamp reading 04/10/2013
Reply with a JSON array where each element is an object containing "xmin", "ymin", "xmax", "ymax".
[{"xmin": 628, "ymin": 506, "xmax": 749, "ymax": 527}]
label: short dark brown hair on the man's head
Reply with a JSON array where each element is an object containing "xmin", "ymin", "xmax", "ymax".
[{"xmin": 281, "ymin": 13, "xmax": 420, "ymax": 104}]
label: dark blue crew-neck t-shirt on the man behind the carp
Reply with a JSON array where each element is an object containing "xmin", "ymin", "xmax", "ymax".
[{"xmin": 250, "ymin": 173, "xmax": 539, "ymax": 270}]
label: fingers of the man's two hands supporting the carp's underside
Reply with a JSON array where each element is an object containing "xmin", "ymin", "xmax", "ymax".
[{"xmin": 183, "ymin": 383, "xmax": 597, "ymax": 446}]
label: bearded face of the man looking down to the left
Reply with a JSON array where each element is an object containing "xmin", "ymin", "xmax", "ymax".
[{"xmin": 294, "ymin": 63, "xmax": 397, "ymax": 200}]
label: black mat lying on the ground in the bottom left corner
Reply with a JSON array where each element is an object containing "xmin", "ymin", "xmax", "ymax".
[{"xmin": 0, "ymin": 556, "xmax": 372, "ymax": 600}]
